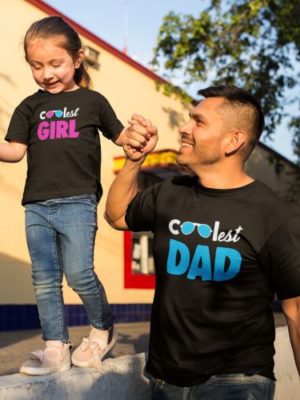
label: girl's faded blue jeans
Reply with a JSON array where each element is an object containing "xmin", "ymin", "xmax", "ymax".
[{"xmin": 25, "ymin": 195, "xmax": 113, "ymax": 342}]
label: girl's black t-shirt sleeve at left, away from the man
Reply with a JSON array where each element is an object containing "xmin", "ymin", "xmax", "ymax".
[{"xmin": 5, "ymin": 101, "xmax": 31, "ymax": 144}]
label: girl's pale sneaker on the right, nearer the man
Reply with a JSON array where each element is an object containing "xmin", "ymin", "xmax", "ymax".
[{"xmin": 72, "ymin": 328, "xmax": 118, "ymax": 371}]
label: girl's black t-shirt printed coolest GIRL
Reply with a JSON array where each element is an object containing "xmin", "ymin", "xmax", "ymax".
[{"xmin": 5, "ymin": 88, "xmax": 123, "ymax": 204}]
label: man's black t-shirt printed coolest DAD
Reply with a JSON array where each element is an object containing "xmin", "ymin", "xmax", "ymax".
[{"xmin": 126, "ymin": 177, "xmax": 300, "ymax": 386}]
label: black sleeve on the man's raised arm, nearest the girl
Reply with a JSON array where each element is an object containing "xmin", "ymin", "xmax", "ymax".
[{"xmin": 125, "ymin": 183, "xmax": 161, "ymax": 232}]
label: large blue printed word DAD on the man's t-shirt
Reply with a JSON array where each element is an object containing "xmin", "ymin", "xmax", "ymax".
[{"xmin": 167, "ymin": 239, "xmax": 242, "ymax": 282}]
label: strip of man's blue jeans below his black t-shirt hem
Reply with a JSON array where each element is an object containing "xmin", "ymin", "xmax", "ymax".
[{"xmin": 150, "ymin": 374, "xmax": 275, "ymax": 400}]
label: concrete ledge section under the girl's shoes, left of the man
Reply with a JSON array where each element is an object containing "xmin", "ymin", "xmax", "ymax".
[{"xmin": 0, "ymin": 354, "xmax": 149, "ymax": 400}]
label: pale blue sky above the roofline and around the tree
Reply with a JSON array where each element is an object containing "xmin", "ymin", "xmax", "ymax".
[{"xmin": 44, "ymin": 0, "xmax": 295, "ymax": 161}]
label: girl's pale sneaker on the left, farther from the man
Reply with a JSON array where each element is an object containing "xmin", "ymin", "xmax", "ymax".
[{"xmin": 20, "ymin": 340, "xmax": 71, "ymax": 375}]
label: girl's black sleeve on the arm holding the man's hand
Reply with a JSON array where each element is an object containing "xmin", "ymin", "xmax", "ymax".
[{"xmin": 99, "ymin": 97, "xmax": 124, "ymax": 140}]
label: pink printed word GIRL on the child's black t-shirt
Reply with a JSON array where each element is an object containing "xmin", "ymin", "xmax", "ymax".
[{"xmin": 37, "ymin": 119, "xmax": 79, "ymax": 140}]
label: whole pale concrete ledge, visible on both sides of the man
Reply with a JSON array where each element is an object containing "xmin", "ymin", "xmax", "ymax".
[{"xmin": 0, "ymin": 327, "xmax": 300, "ymax": 400}]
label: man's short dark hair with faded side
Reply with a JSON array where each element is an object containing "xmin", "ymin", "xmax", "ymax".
[{"xmin": 198, "ymin": 86, "xmax": 264, "ymax": 147}]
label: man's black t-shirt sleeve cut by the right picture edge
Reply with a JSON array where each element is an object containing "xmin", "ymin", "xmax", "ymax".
[{"xmin": 260, "ymin": 216, "xmax": 300, "ymax": 300}]
